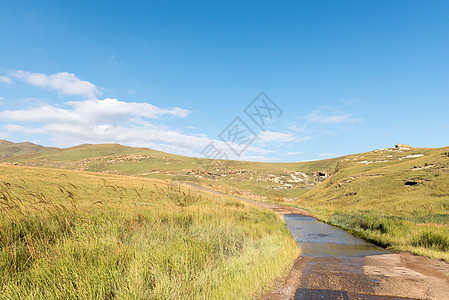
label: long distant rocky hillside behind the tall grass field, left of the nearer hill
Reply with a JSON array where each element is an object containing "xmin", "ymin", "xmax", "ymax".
[{"xmin": 2, "ymin": 144, "xmax": 337, "ymax": 198}]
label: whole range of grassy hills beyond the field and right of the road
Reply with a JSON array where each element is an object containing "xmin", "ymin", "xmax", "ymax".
[{"xmin": 2, "ymin": 140, "xmax": 449, "ymax": 260}]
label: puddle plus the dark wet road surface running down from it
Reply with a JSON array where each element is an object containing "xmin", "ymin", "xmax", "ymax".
[{"xmin": 284, "ymin": 214, "xmax": 416, "ymax": 300}]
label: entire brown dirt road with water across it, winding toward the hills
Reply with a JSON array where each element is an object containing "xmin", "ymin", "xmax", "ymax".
[{"xmin": 181, "ymin": 184, "xmax": 449, "ymax": 300}]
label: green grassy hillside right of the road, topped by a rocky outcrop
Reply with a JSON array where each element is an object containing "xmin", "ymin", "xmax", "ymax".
[{"xmin": 290, "ymin": 147, "xmax": 449, "ymax": 261}]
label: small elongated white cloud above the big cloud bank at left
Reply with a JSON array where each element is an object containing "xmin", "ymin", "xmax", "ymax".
[{"xmin": 12, "ymin": 71, "xmax": 101, "ymax": 99}]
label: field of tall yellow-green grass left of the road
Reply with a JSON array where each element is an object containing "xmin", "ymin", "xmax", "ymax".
[{"xmin": 0, "ymin": 166, "xmax": 298, "ymax": 299}]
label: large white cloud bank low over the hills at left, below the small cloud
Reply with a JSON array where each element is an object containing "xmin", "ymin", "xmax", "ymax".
[{"xmin": 0, "ymin": 99, "xmax": 272, "ymax": 161}]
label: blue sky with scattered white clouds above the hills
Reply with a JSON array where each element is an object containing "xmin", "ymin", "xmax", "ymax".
[{"xmin": 0, "ymin": 0, "xmax": 449, "ymax": 161}]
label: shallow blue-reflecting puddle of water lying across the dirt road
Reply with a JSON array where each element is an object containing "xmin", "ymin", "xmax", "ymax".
[{"xmin": 284, "ymin": 214, "xmax": 391, "ymax": 257}]
